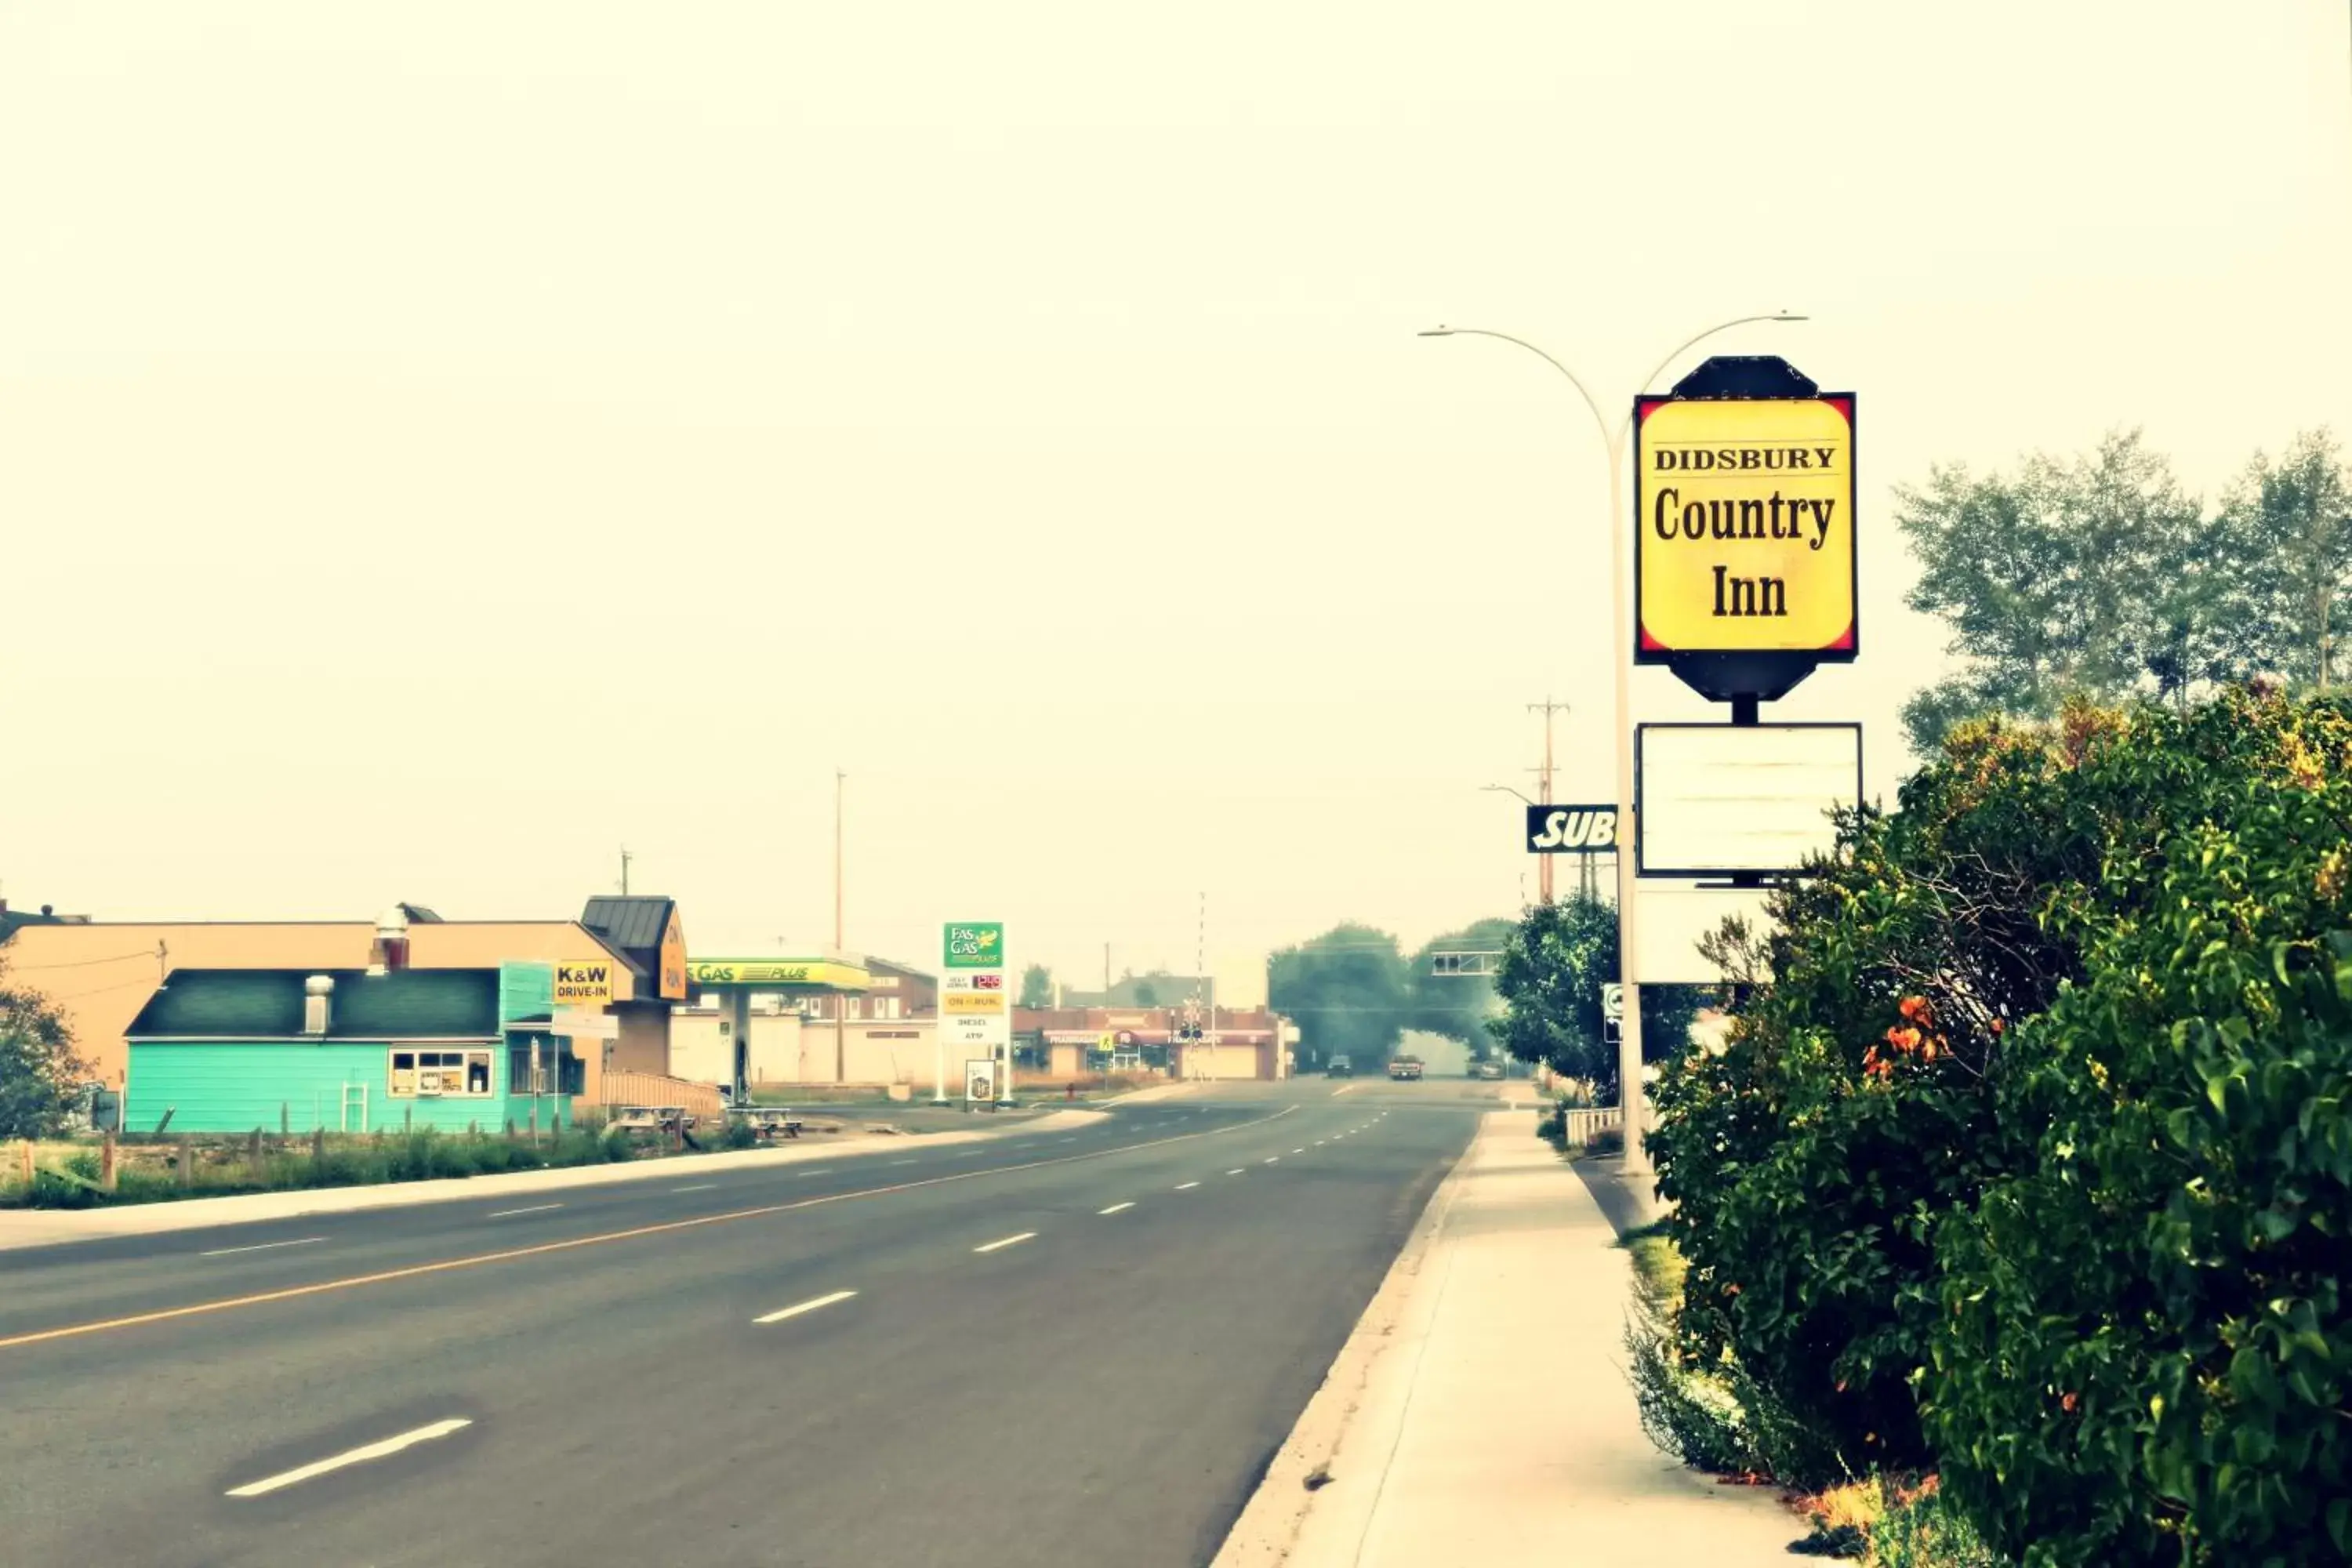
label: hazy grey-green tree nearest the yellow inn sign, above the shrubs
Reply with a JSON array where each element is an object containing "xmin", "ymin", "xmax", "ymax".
[{"xmin": 1896, "ymin": 430, "xmax": 2201, "ymax": 755}]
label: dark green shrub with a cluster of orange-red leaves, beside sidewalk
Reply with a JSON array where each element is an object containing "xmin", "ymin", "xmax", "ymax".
[{"xmin": 1653, "ymin": 710, "xmax": 2096, "ymax": 1486}]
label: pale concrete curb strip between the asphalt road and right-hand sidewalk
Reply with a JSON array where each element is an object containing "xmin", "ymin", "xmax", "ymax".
[{"xmin": 1211, "ymin": 1109, "xmax": 1484, "ymax": 1568}]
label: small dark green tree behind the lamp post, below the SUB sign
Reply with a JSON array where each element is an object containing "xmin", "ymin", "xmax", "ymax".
[{"xmin": 1486, "ymin": 893, "xmax": 1700, "ymax": 1105}]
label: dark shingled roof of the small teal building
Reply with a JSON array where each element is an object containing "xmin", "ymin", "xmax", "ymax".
[{"xmin": 125, "ymin": 968, "xmax": 499, "ymax": 1039}]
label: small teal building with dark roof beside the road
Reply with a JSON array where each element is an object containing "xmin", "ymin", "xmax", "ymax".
[{"xmin": 122, "ymin": 964, "xmax": 583, "ymax": 1133}]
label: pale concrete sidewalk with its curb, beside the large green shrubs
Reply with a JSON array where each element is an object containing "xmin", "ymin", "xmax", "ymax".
[{"xmin": 1216, "ymin": 1112, "xmax": 1806, "ymax": 1568}]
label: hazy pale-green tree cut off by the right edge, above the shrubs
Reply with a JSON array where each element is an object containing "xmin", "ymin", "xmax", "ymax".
[{"xmin": 2220, "ymin": 430, "xmax": 2352, "ymax": 687}]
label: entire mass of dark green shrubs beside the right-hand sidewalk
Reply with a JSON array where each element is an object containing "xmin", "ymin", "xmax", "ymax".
[{"xmin": 1656, "ymin": 691, "xmax": 2352, "ymax": 1566}]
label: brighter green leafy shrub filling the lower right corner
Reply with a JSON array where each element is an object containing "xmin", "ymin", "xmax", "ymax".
[{"xmin": 1924, "ymin": 706, "xmax": 2352, "ymax": 1568}]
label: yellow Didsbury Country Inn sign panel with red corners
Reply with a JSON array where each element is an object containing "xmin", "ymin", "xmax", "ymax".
[{"xmin": 1635, "ymin": 393, "xmax": 1858, "ymax": 663}]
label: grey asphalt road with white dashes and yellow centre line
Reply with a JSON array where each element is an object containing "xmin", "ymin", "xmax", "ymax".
[{"xmin": 0, "ymin": 1079, "xmax": 1501, "ymax": 1568}]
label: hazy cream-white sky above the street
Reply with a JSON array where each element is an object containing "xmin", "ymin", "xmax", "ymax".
[{"xmin": 0, "ymin": 0, "xmax": 2352, "ymax": 1001}]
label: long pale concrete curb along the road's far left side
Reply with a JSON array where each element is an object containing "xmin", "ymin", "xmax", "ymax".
[{"xmin": 0, "ymin": 1109, "xmax": 1103, "ymax": 1250}]
